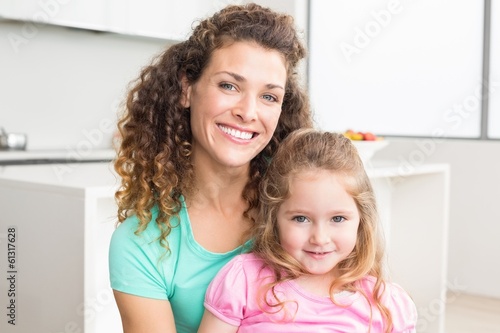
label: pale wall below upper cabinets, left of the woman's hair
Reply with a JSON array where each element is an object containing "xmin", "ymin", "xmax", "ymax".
[{"xmin": 0, "ymin": 21, "xmax": 166, "ymax": 150}]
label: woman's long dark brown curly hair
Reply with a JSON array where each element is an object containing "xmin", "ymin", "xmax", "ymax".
[{"xmin": 114, "ymin": 4, "xmax": 312, "ymax": 249}]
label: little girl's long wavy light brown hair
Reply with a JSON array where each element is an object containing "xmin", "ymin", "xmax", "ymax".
[{"xmin": 252, "ymin": 129, "xmax": 392, "ymax": 332}]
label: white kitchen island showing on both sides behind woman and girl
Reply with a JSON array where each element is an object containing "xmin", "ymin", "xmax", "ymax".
[{"xmin": 0, "ymin": 163, "xmax": 449, "ymax": 333}]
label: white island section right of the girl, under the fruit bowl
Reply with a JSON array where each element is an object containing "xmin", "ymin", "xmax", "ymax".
[{"xmin": 367, "ymin": 163, "xmax": 453, "ymax": 333}]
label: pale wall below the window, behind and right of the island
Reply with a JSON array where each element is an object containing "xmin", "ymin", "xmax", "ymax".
[{"xmin": 374, "ymin": 138, "xmax": 500, "ymax": 298}]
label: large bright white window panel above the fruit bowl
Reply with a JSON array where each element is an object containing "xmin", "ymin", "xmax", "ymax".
[{"xmin": 309, "ymin": 0, "xmax": 484, "ymax": 138}]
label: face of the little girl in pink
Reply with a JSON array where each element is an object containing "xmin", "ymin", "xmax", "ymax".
[{"xmin": 277, "ymin": 169, "xmax": 360, "ymax": 276}]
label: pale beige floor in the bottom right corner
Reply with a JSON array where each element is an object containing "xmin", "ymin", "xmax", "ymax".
[{"xmin": 445, "ymin": 294, "xmax": 500, "ymax": 333}]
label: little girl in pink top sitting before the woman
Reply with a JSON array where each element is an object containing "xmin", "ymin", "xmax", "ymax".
[{"xmin": 198, "ymin": 129, "xmax": 417, "ymax": 333}]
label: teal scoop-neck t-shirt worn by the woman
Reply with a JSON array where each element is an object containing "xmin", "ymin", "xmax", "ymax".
[{"xmin": 109, "ymin": 203, "xmax": 250, "ymax": 333}]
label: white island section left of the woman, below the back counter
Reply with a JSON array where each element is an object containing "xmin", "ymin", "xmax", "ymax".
[{"xmin": 0, "ymin": 163, "xmax": 121, "ymax": 333}]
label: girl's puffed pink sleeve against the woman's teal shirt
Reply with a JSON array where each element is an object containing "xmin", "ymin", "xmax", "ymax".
[{"xmin": 204, "ymin": 255, "xmax": 248, "ymax": 326}]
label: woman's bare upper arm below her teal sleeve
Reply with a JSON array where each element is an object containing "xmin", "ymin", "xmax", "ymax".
[{"xmin": 113, "ymin": 290, "xmax": 178, "ymax": 333}]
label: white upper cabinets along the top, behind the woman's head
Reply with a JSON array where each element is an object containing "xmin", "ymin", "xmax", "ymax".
[{"xmin": 0, "ymin": 0, "xmax": 307, "ymax": 41}]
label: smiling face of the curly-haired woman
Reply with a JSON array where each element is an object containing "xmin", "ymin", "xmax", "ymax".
[{"xmin": 182, "ymin": 42, "xmax": 287, "ymax": 168}]
